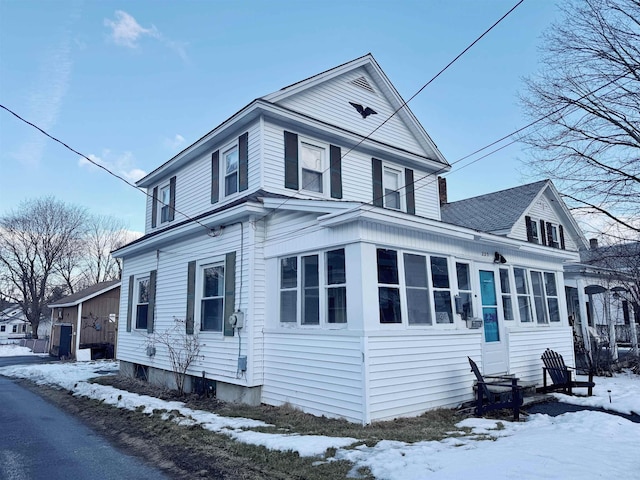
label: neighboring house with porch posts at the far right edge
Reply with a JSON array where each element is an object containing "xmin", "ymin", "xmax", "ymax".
[{"xmin": 565, "ymin": 239, "xmax": 640, "ymax": 360}]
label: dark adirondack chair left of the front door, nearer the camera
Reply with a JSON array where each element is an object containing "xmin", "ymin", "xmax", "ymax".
[{"xmin": 467, "ymin": 357, "xmax": 523, "ymax": 420}]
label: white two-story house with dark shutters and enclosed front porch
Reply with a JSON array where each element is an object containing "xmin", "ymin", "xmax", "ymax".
[{"xmin": 115, "ymin": 55, "xmax": 585, "ymax": 423}]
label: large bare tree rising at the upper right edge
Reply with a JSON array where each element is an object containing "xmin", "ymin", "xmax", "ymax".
[{"xmin": 521, "ymin": 0, "xmax": 640, "ymax": 239}]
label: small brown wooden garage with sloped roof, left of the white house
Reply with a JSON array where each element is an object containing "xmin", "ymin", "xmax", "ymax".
[{"xmin": 48, "ymin": 280, "xmax": 120, "ymax": 359}]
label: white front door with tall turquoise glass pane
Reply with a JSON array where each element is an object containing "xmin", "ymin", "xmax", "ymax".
[{"xmin": 479, "ymin": 269, "xmax": 509, "ymax": 375}]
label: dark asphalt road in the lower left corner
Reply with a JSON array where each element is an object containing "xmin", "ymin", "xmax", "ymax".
[{"xmin": 0, "ymin": 357, "xmax": 167, "ymax": 480}]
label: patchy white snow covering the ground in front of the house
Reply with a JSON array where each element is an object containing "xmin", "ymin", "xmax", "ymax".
[{"xmin": 0, "ymin": 347, "xmax": 640, "ymax": 480}]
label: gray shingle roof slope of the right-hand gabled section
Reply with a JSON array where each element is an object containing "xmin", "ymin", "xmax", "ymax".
[{"xmin": 440, "ymin": 180, "xmax": 548, "ymax": 232}]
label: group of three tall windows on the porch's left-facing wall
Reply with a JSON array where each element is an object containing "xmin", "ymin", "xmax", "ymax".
[{"xmin": 280, "ymin": 248, "xmax": 347, "ymax": 326}]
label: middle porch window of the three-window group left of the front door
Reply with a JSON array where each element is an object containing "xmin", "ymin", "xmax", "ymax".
[{"xmin": 404, "ymin": 253, "xmax": 432, "ymax": 325}]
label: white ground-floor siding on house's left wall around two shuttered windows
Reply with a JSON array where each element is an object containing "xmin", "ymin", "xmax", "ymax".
[{"xmin": 117, "ymin": 223, "xmax": 256, "ymax": 386}]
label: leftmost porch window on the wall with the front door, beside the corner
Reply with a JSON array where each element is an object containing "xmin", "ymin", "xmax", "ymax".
[{"xmin": 377, "ymin": 248, "xmax": 402, "ymax": 323}]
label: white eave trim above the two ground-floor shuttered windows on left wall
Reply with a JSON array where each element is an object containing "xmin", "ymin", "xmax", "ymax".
[{"xmin": 114, "ymin": 202, "xmax": 265, "ymax": 258}]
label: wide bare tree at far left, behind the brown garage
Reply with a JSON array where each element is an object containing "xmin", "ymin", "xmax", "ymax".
[{"xmin": 0, "ymin": 197, "xmax": 87, "ymax": 338}]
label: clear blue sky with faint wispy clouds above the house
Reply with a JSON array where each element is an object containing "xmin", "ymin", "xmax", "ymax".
[{"xmin": 0, "ymin": 0, "xmax": 559, "ymax": 231}]
